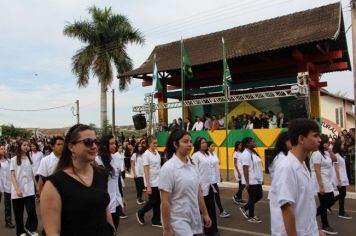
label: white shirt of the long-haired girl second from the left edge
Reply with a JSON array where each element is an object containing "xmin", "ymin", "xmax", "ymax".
[{"xmin": 10, "ymin": 156, "xmax": 35, "ymax": 199}]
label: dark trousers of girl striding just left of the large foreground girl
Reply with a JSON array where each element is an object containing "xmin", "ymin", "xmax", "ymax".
[{"xmin": 138, "ymin": 187, "xmax": 161, "ymax": 224}]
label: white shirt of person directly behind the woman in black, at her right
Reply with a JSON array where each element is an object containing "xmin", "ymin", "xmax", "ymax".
[{"xmin": 95, "ymin": 155, "xmax": 124, "ymax": 213}]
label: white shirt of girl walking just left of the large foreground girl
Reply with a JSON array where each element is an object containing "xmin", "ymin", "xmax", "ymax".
[{"xmin": 142, "ymin": 150, "xmax": 161, "ymax": 187}]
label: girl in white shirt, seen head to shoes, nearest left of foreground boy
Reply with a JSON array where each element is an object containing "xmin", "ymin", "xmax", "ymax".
[{"xmin": 240, "ymin": 137, "xmax": 263, "ymax": 223}]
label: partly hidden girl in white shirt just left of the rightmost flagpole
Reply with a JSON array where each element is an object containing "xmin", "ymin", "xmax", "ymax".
[{"xmin": 208, "ymin": 142, "xmax": 230, "ymax": 218}]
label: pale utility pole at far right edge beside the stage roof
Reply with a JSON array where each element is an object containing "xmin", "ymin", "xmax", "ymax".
[{"xmin": 350, "ymin": 0, "xmax": 356, "ymax": 189}]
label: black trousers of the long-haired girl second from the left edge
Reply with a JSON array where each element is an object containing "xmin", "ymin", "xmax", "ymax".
[{"xmin": 12, "ymin": 195, "xmax": 38, "ymax": 236}]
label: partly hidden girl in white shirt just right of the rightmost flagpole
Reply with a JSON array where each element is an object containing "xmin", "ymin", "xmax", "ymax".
[{"xmin": 232, "ymin": 141, "xmax": 246, "ymax": 205}]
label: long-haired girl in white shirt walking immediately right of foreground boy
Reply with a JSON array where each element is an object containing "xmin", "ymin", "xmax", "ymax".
[{"xmin": 310, "ymin": 134, "xmax": 338, "ymax": 234}]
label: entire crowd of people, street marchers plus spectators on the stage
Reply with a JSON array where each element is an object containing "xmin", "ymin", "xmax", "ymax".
[{"xmin": 0, "ymin": 119, "xmax": 355, "ymax": 236}]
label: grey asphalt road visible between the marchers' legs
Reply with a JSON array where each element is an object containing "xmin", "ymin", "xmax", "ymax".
[{"xmin": 0, "ymin": 178, "xmax": 356, "ymax": 236}]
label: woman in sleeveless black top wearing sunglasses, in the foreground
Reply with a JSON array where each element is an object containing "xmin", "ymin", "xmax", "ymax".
[{"xmin": 40, "ymin": 124, "xmax": 115, "ymax": 236}]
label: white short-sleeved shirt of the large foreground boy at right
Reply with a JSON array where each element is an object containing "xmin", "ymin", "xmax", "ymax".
[{"xmin": 268, "ymin": 152, "xmax": 319, "ymax": 236}]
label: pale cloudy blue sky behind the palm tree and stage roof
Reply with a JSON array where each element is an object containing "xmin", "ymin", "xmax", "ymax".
[{"xmin": 0, "ymin": 0, "xmax": 353, "ymax": 128}]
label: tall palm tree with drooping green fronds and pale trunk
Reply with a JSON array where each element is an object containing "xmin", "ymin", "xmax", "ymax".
[{"xmin": 63, "ymin": 6, "xmax": 144, "ymax": 128}]
